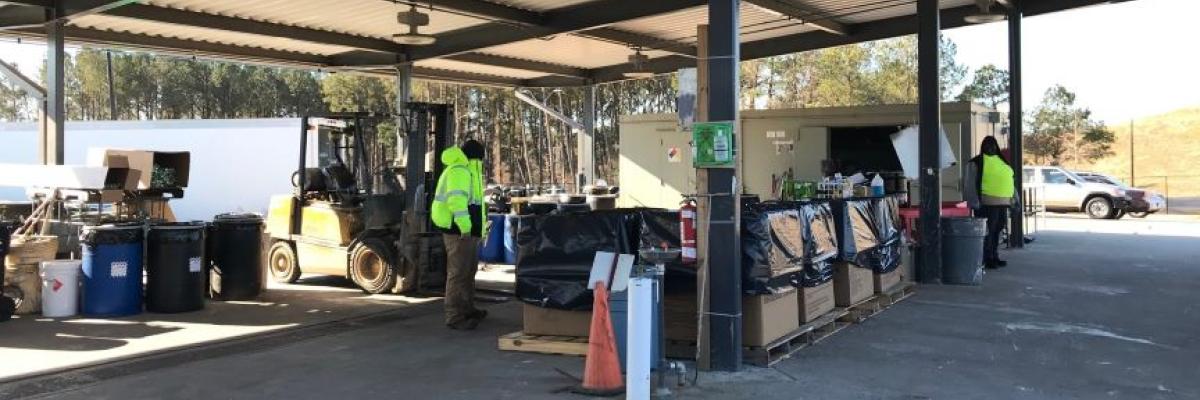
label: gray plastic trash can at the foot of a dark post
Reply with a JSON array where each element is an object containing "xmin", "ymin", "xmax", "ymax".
[{"xmin": 942, "ymin": 217, "xmax": 988, "ymax": 285}]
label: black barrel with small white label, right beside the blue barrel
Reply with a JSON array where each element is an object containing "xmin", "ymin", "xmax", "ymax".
[{"xmin": 146, "ymin": 222, "xmax": 205, "ymax": 312}]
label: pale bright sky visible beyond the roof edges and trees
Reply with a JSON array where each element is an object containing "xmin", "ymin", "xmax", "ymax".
[{"xmin": 0, "ymin": 0, "xmax": 1200, "ymax": 123}]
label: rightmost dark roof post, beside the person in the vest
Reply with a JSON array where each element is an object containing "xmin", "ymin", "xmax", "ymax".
[{"xmin": 1008, "ymin": 1, "xmax": 1025, "ymax": 249}]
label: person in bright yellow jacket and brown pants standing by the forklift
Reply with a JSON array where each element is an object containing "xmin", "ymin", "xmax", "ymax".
[{"xmin": 430, "ymin": 139, "xmax": 487, "ymax": 330}]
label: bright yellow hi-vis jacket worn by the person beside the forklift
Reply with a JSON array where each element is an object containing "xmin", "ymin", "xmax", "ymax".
[{"xmin": 430, "ymin": 147, "xmax": 487, "ymax": 237}]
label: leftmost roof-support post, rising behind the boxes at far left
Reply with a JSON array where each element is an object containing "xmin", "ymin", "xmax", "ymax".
[{"xmin": 37, "ymin": 5, "xmax": 66, "ymax": 166}]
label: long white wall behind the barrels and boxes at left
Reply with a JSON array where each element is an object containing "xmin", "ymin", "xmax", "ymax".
[{"xmin": 0, "ymin": 118, "xmax": 300, "ymax": 220}]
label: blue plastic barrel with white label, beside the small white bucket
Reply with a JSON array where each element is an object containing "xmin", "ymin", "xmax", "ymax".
[{"xmin": 80, "ymin": 225, "xmax": 144, "ymax": 317}]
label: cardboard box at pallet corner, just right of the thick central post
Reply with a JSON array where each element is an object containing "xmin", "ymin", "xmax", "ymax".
[{"xmin": 742, "ymin": 288, "xmax": 800, "ymax": 346}]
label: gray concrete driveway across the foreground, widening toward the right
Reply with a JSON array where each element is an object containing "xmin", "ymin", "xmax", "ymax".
[{"xmin": 0, "ymin": 219, "xmax": 1200, "ymax": 400}]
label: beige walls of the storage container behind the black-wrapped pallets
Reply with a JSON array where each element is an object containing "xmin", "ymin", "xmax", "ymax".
[{"xmin": 618, "ymin": 102, "xmax": 989, "ymax": 208}]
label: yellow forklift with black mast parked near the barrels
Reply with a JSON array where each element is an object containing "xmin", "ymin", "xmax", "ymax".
[{"xmin": 266, "ymin": 103, "xmax": 454, "ymax": 293}]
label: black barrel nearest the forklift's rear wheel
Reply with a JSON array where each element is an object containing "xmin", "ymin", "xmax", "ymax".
[{"xmin": 208, "ymin": 214, "xmax": 266, "ymax": 300}]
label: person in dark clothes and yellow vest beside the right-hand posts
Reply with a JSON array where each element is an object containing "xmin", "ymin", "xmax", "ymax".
[{"xmin": 962, "ymin": 136, "xmax": 1016, "ymax": 269}]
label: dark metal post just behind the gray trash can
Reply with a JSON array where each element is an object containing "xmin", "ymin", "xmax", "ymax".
[{"xmin": 917, "ymin": 0, "xmax": 942, "ymax": 283}]
